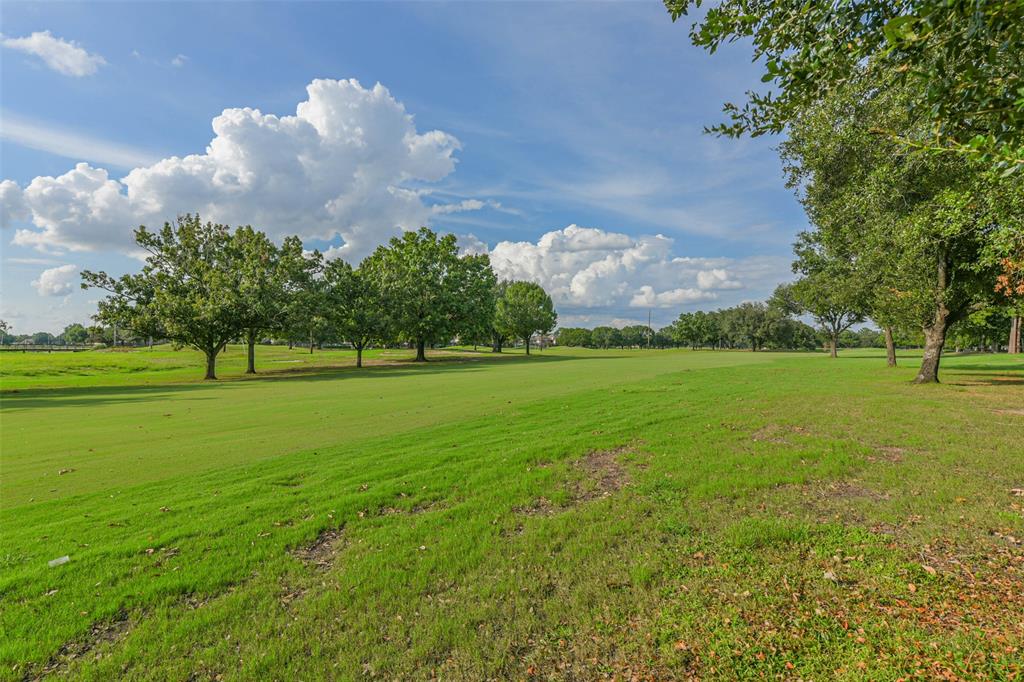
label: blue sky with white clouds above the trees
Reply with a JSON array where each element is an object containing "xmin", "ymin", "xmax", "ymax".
[{"xmin": 0, "ymin": 2, "xmax": 806, "ymax": 333}]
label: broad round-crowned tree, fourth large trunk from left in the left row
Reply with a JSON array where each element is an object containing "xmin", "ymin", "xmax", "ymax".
[{"xmin": 360, "ymin": 227, "xmax": 494, "ymax": 363}]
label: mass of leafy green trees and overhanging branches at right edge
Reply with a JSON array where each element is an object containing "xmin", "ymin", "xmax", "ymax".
[{"xmin": 666, "ymin": 0, "xmax": 1024, "ymax": 383}]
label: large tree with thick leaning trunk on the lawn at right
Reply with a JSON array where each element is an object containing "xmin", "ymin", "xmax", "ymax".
[{"xmin": 780, "ymin": 78, "xmax": 1003, "ymax": 383}]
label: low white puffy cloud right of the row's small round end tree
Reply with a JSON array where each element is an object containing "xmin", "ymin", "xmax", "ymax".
[{"xmin": 490, "ymin": 225, "xmax": 742, "ymax": 309}]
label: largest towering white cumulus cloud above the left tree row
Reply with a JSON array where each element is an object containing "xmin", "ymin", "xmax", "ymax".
[{"xmin": 2, "ymin": 80, "xmax": 464, "ymax": 259}]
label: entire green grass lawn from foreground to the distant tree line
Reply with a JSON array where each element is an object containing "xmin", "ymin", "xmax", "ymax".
[{"xmin": 0, "ymin": 348, "xmax": 1024, "ymax": 680}]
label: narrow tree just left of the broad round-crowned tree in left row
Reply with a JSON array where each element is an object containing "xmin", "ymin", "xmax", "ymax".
[{"xmin": 324, "ymin": 258, "xmax": 387, "ymax": 368}]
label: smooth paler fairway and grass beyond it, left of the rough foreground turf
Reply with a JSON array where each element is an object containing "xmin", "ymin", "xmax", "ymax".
[{"xmin": 0, "ymin": 348, "xmax": 775, "ymax": 505}]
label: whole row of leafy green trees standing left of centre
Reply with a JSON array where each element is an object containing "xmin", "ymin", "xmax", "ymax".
[{"xmin": 82, "ymin": 215, "xmax": 557, "ymax": 379}]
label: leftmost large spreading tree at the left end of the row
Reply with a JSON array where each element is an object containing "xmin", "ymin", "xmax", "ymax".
[{"xmin": 82, "ymin": 215, "xmax": 244, "ymax": 380}]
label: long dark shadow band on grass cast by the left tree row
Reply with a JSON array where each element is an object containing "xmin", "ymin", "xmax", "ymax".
[{"xmin": 0, "ymin": 353, "xmax": 589, "ymax": 414}]
